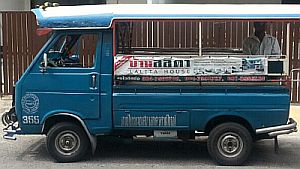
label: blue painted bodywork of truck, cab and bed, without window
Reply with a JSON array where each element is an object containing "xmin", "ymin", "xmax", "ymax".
[{"xmin": 16, "ymin": 30, "xmax": 290, "ymax": 135}]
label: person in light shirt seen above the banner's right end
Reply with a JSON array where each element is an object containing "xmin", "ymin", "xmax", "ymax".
[{"xmin": 243, "ymin": 22, "xmax": 281, "ymax": 55}]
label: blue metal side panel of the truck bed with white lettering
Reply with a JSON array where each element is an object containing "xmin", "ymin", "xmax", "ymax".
[{"xmin": 113, "ymin": 85, "xmax": 290, "ymax": 131}]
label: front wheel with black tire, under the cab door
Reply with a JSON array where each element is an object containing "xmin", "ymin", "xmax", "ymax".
[{"xmin": 46, "ymin": 122, "xmax": 90, "ymax": 162}]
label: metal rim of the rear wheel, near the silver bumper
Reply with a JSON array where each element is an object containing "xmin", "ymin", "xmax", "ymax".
[{"xmin": 218, "ymin": 132, "xmax": 244, "ymax": 158}]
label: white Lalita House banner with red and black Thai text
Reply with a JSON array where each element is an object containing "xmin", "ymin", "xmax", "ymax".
[{"xmin": 115, "ymin": 55, "xmax": 267, "ymax": 76}]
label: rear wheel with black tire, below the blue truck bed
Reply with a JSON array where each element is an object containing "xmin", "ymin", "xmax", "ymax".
[{"xmin": 207, "ymin": 123, "xmax": 253, "ymax": 165}]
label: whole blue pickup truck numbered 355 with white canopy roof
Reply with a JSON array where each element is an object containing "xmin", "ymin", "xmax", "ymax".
[{"xmin": 2, "ymin": 5, "xmax": 300, "ymax": 165}]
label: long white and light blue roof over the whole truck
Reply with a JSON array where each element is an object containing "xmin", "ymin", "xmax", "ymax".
[{"xmin": 32, "ymin": 4, "xmax": 300, "ymax": 29}]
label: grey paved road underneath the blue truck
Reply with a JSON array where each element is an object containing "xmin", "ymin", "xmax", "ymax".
[{"xmin": 0, "ymin": 97, "xmax": 300, "ymax": 169}]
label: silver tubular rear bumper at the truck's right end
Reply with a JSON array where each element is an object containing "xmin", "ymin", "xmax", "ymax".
[{"xmin": 256, "ymin": 118, "xmax": 297, "ymax": 137}]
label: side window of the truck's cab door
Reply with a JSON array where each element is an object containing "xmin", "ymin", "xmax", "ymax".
[{"xmin": 46, "ymin": 33, "xmax": 99, "ymax": 68}]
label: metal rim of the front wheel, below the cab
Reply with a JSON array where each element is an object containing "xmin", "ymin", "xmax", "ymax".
[{"xmin": 55, "ymin": 130, "xmax": 80, "ymax": 155}]
